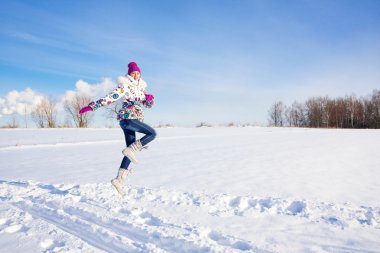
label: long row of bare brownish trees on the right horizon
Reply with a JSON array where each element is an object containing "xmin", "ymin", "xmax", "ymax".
[{"xmin": 269, "ymin": 90, "xmax": 380, "ymax": 128}]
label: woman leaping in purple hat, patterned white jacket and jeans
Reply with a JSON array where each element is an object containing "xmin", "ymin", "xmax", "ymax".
[{"xmin": 79, "ymin": 62, "xmax": 156, "ymax": 195}]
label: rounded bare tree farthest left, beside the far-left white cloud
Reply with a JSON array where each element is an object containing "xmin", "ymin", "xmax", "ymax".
[{"xmin": 32, "ymin": 97, "xmax": 57, "ymax": 128}]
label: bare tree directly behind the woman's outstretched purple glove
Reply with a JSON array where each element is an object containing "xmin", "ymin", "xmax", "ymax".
[{"xmin": 64, "ymin": 94, "xmax": 92, "ymax": 127}]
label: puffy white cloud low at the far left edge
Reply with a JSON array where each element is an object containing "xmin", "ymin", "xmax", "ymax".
[{"xmin": 0, "ymin": 88, "xmax": 44, "ymax": 115}]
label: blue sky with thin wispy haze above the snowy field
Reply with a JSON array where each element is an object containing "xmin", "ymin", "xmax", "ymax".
[{"xmin": 0, "ymin": 0, "xmax": 380, "ymax": 126}]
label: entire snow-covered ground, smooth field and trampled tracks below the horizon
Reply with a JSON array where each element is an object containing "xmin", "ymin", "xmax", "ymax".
[{"xmin": 0, "ymin": 127, "xmax": 380, "ymax": 252}]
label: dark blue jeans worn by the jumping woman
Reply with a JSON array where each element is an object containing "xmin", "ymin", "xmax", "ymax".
[{"xmin": 120, "ymin": 119, "xmax": 157, "ymax": 169}]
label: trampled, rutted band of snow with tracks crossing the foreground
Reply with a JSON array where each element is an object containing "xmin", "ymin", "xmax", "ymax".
[{"xmin": 0, "ymin": 181, "xmax": 380, "ymax": 252}]
